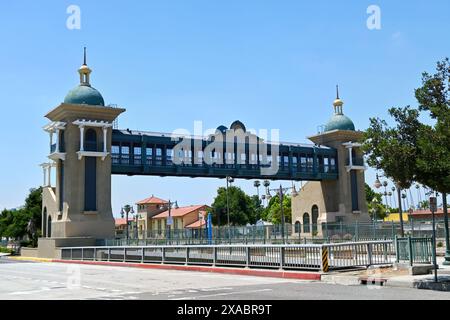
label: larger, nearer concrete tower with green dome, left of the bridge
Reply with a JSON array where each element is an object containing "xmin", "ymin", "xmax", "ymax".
[{"xmin": 39, "ymin": 49, "xmax": 125, "ymax": 256}]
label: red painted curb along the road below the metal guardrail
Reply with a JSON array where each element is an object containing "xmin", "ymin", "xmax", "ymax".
[{"xmin": 52, "ymin": 259, "xmax": 321, "ymax": 281}]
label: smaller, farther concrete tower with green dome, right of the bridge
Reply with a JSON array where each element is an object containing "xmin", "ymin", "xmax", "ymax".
[{"xmin": 292, "ymin": 88, "xmax": 370, "ymax": 235}]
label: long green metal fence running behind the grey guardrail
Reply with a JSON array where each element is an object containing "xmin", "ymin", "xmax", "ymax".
[{"xmin": 115, "ymin": 221, "xmax": 445, "ymax": 245}]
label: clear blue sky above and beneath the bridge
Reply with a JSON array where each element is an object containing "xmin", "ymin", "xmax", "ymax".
[{"xmin": 0, "ymin": 0, "xmax": 450, "ymax": 215}]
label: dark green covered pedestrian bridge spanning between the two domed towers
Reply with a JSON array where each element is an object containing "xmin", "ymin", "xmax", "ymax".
[{"xmin": 111, "ymin": 130, "xmax": 338, "ymax": 181}]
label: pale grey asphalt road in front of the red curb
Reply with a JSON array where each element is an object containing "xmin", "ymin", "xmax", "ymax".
[{"xmin": 0, "ymin": 258, "xmax": 450, "ymax": 300}]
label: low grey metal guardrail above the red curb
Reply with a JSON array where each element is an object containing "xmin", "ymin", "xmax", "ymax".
[{"xmin": 61, "ymin": 240, "xmax": 396, "ymax": 272}]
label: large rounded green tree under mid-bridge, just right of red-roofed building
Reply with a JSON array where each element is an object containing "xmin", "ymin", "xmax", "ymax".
[{"xmin": 211, "ymin": 186, "xmax": 257, "ymax": 226}]
